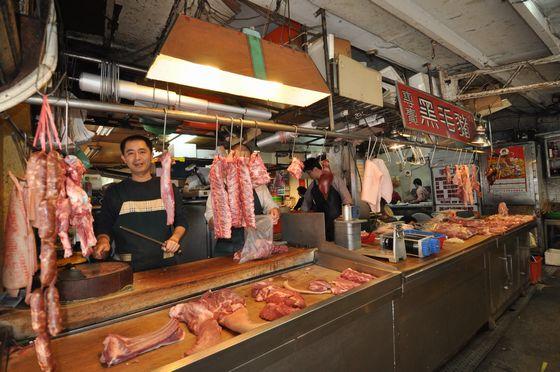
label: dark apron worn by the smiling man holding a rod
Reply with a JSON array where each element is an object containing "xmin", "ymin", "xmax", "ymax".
[{"xmin": 113, "ymin": 202, "xmax": 177, "ymax": 272}]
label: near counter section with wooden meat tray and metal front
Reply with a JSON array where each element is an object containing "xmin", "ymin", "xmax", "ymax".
[{"xmin": 8, "ymin": 246, "xmax": 401, "ymax": 371}]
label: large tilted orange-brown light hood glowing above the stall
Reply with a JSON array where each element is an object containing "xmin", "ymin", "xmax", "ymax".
[{"xmin": 147, "ymin": 16, "xmax": 330, "ymax": 106}]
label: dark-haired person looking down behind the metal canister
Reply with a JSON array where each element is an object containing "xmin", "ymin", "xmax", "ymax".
[{"xmin": 301, "ymin": 158, "xmax": 352, "ymax": 241}]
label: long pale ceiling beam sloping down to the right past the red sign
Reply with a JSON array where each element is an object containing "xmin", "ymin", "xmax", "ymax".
[{"xmin": 370, "ymin": 0, "xmax": 544, "ymax": 107}]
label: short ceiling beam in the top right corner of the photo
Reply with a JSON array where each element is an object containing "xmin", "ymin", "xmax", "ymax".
[{"xmin": 509, "ymin": 0, "xmax": 560, "ymax": 54}]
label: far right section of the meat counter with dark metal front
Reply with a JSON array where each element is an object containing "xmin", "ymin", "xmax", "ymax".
[{"xmin": 336, "ymin": 222, "xmax": 537, "ymax": 371}]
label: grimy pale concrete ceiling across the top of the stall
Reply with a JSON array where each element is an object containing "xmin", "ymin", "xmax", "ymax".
[{"xmin": 63, "ymin": 0, "xmax": 560, "ymax": 119}]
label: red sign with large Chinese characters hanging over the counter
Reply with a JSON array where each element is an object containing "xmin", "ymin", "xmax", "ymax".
[{"xmin": 397, "ymin": 82, "xmax": 475, "ymax": 143}]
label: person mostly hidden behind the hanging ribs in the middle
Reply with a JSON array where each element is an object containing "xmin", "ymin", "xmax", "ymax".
[{"xmin": 204, "ymin": 144, "xmax": 280, "ymax": 257}]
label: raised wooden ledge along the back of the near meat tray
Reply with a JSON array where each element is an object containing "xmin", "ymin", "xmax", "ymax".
[{"xmin": 0, "ymin": 248, "xmax": 314, "ymax": 340}]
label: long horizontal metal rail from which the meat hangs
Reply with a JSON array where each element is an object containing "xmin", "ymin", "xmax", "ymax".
[{"xmin": 25, "ymin": 95, "xmax": 486, "ymax": 154}]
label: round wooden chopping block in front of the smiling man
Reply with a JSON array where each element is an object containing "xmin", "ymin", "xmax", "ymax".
[{"xmin": 56, "ymin": 262, "xmax": 132, "ymax": 301}]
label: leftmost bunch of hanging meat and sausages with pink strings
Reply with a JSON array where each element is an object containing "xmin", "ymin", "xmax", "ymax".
[{"xmin": 3, "ymin": 96, "xmax": 96, "ymax": 371}]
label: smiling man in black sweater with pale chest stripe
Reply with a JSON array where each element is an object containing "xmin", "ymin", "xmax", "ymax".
[{"xmin": 94, "ymin": 135, "xmax": 187, "ymax": 271}]
